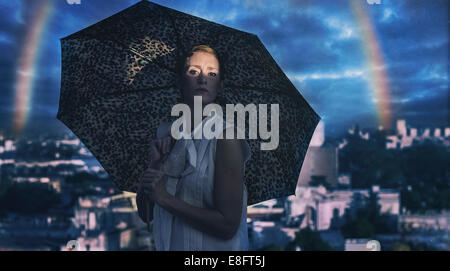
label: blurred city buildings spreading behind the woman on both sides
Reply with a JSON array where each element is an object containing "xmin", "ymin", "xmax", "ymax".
[{"xmin": 0, "ymin": 117, "xmax": 450, "ymax": 253}]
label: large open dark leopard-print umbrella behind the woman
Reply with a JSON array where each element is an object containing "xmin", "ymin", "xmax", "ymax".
[{"xmin": 57, "ymin": 0, "xmax": 320, "ymax": 205}]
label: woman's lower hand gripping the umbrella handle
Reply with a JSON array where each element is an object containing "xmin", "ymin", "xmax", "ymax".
[{"xmin": 139, "ymin": 167, "xmax": 168, "ymax": 203}]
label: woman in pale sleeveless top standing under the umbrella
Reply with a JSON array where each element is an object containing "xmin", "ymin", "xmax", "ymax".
[{"xmin": 137, "ymin": 45, "xmax": 250, "ymax": 250}]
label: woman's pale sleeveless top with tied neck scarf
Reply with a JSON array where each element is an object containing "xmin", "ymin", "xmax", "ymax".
[{"xmin": 153, "ymin": 115, "xmax": 250, "ymax": 251}]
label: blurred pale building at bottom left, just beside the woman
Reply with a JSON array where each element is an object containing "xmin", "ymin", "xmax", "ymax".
[{"xmin": 68, "ymin": 192, "xmax": 154, "ymax": 251}]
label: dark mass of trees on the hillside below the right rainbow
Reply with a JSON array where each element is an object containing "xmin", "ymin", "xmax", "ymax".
[{"xmin": 339, "ymin": 127, "xmax": 450, "ymax": 213}]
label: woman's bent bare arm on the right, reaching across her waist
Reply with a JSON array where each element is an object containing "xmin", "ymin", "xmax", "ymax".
[{"xmin": 157, "ymin": 131, "xmax": 244, "ymax": 240}]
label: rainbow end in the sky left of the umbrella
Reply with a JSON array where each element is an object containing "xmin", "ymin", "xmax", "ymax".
[{"xmin": 12, "ymin": 0, "xmax": 53, "ymax": 135}]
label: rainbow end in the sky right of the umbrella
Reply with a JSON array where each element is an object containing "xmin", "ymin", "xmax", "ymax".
[{"xmin": 350, "ymin": 0, "xmax": 392, "ymax": 129}]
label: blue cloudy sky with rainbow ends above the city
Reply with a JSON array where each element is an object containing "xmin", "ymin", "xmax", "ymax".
[{"xmin": 0, "ymin": 0, "xmax": 450, "ymax": 136}]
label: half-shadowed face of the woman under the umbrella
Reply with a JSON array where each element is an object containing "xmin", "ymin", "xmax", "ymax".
[{"xmin": 177, "ymin": 51, "xmax": 223, "ymax": 105}]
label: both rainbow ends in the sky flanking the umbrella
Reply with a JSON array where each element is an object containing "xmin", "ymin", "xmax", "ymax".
[{"xmin": 8, "ymin": 0, "xmax": 391, "ymax": 134}]
